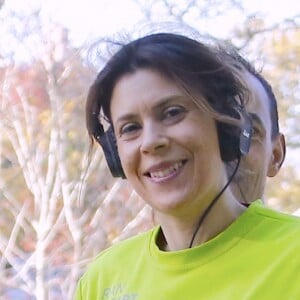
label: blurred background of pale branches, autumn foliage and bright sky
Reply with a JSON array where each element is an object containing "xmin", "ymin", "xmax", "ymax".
[{"xmin": 0, "ymin": 0, "xmax": 300, "ymax": 300}]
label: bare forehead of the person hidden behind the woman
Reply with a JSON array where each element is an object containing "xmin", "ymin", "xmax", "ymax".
[{"xmin": 243, "ymin": 71, "xmax": 271, "ymax": 132}]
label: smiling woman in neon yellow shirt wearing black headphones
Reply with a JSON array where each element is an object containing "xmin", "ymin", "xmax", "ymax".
[{"xmin": 75, "ymin": 33, "xmax": 300, "ymax": 300}]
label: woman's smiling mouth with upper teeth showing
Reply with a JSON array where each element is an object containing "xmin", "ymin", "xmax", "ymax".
[{"xmin": 143, "ymin": 160, "xmax": 187, "ymax": 183}]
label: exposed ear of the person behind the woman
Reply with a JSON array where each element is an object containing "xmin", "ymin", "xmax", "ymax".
[{"xmin": 267, "ymin": 133, "xmax": 286, "ymax": 177}]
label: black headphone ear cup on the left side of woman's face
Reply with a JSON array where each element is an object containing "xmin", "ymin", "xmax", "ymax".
[{"xmin": 95, "ymin": 126, "xmax": 126, "ymax": 178}]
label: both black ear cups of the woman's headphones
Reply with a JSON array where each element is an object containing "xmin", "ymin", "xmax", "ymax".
[{"xmin": 93, "ymin": 107, "xmax": 252, "ymax": 178}]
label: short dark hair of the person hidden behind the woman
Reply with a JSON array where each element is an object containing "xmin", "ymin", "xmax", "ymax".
[{"xmin": 218, "ymin": 46, "xmax": 279, "ymax": 140}]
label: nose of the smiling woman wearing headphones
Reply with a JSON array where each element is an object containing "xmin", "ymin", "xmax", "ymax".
[{"xmin": 140, "ymin": 123, "xmax": 170, "ymax": 154}]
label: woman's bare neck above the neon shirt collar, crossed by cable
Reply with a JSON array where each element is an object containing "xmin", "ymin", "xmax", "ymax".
[{"xmin": 157, "ymin": 197, "xmax": 246, "ymax": 251}]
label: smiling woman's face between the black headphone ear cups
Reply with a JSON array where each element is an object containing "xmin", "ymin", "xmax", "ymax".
[{"xmin": 111, "ymin": 69, "xmax": 227, "ymax": 216}]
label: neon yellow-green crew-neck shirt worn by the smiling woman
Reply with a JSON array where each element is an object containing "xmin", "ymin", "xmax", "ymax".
[{"xmin": 75, "ymin": 201, "xmax": 300, "ymax": 300}]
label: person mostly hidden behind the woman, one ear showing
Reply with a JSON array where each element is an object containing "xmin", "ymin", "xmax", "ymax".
[{"xmin": 220, "ymin": 45, "xmax": 286, "ymax": 203}]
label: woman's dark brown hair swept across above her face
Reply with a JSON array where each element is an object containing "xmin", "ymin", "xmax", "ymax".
[{"xmin": 86, "ymin": 33, "xmax": 245, "ymax": 137}]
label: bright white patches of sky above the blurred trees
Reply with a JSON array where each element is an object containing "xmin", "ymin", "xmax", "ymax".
[{"xmin": 0, "ymin": 0, "xmax": 300, "ymax": 45}]
